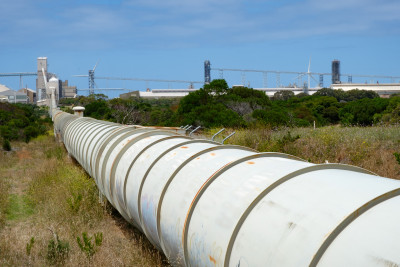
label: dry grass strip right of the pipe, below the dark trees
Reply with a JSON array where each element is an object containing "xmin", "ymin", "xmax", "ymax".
[{"xmin": 208, "ymin": 126, "xmax": 400, "ymax": 179}]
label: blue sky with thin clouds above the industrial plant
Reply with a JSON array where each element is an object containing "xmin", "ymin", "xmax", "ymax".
[{"xmin": 0, "ymin": 0, "xmax": 400, "ymax": 96}]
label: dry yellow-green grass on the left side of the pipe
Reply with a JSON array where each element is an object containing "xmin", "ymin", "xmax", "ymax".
[{"xmin": 0, "ymin": 133, "xmax": 167, "ymax": 266}]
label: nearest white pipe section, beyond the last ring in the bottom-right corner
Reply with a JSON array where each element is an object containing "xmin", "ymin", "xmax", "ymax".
[{"xmin": 318, "ymin": 196, "xmax": 400, "ymax": 267}]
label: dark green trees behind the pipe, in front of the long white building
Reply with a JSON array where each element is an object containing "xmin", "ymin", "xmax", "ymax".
[{"xmin": 60, "ymin": 79, "xmax": 400, "ymax": 128}]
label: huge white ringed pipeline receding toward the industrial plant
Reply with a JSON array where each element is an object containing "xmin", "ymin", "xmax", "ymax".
[{"xmin": 50, "ymin": 91, "xmax": 400, "ymax": 267}]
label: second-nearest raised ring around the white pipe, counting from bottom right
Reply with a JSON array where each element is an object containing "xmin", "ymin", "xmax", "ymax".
[{"xmin": 224, "ymin": 163, "xmax": 373, "ymax": 267}]
